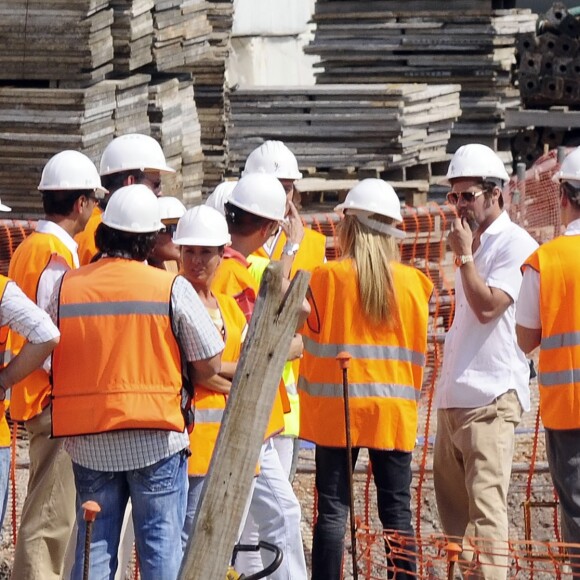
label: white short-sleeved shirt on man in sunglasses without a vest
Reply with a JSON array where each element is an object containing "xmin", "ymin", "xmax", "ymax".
[{"xmin": 435, "ymin": 211, "xmax": 538, "ymax": 411}]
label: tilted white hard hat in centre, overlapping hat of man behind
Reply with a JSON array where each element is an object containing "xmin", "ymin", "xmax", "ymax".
[{"xmin": 228, "ymin": 173, "xmax": 286, "ymax": 221}]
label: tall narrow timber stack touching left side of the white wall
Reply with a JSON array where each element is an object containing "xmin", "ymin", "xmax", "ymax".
[{"xmin": 188, "ymin": 0, "xmax": 234, "ymax": 191}]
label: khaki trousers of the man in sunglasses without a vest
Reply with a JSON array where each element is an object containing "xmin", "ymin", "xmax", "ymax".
[{"xmin": 433, "ymin": 391, "xmax": 522, "ymax": 580}]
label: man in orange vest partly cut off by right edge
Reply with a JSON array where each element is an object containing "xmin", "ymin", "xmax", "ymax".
[{"xmin": 516, "ymin": 148, "xmax": 580, "ymax": 574}]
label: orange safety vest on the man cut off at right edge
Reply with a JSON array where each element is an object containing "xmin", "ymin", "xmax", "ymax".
[{"xmin": 522, "ymin": 236, "xmax": 580, "ymax": 429}]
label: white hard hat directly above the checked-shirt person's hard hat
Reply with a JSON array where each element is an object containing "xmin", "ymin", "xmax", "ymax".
[{"xmin": 99, "ymin": 133, "xmax": 175, "ymax": 175}]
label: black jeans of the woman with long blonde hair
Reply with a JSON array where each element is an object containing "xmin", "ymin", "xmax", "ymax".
[{"xmin": 312, "ymin": 445, "xmax": 417, "ymax": 580}]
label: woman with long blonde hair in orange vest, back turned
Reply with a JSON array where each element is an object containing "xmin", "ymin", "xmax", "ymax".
[{"xmin": 299, "ymin": 179, "xmax": 433, "ymax": 580}]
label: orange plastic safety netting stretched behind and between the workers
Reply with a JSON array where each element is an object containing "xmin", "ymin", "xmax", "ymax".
[{"xmin": 0, "ymin": 152, "xmax": 568, "ymax": 580}]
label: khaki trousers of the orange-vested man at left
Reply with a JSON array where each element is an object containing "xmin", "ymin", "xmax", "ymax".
[{"xmin": 12, "ymin": 408, "xmax": 76, "ymax": 580}]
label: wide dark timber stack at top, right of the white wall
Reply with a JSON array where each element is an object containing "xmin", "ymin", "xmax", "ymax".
[{"xmin": 306, "ymin": 0, "xmax": 537, "ymax": 169}]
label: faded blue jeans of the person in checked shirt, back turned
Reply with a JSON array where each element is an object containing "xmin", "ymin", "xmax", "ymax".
[{"xmin": 71, "ymin": 451, "xmax": 187, "ymax": 580}]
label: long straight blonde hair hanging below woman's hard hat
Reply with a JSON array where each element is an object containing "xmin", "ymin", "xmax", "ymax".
[{"xmin": 337, "ymin": 214, "xmax": 400, "ymax": 327}]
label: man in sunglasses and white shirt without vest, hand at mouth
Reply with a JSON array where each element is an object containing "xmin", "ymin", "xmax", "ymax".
[{"xmin": 433, "ymin": 144, "xmax": 537, "ymax": 580}]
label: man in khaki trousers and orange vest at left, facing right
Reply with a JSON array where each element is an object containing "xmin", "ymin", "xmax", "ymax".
[{"xmin": 8, "ymin": 151, "xmax": 106, "ymax": 580}]
